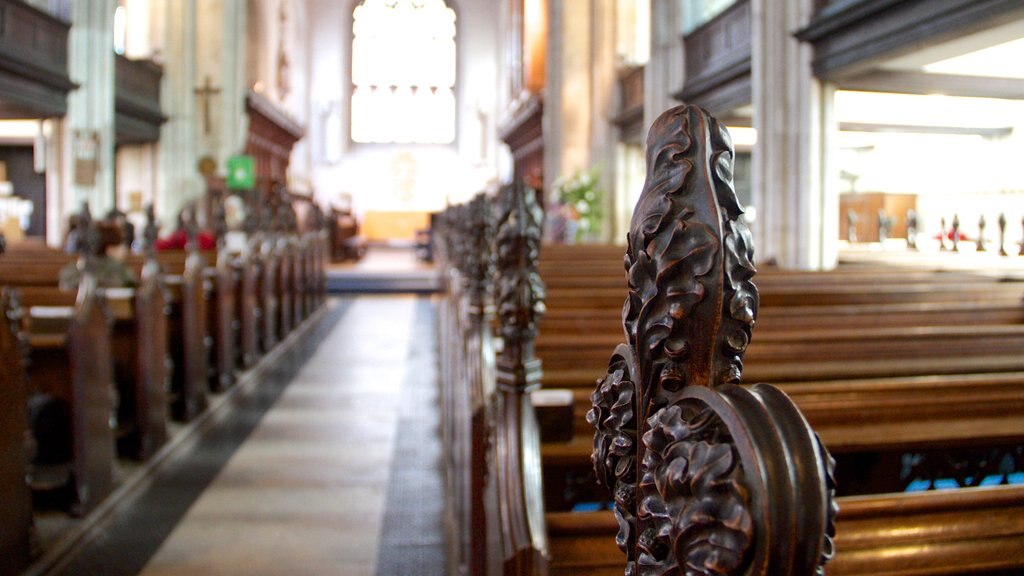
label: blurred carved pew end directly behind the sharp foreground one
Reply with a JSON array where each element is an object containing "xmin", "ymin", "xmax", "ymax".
[{"xmin": 494, "ymin": 184, "xmax": 548, "ymax": 575}]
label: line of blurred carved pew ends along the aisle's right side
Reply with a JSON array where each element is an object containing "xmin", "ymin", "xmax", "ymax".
[{"xmin": 438, "ymin": 188, "xmax": 548, "ymax": 576}]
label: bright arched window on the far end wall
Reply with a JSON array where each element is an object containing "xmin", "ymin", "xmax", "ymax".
[{"xmin": 351, "ymin": 0, "xmax": 456, "ymax": 143}]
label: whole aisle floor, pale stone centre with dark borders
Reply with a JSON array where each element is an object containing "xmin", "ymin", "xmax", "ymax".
[{"xmin": 37, "ymin": 296, "xmax": 444, "ymax": 576}]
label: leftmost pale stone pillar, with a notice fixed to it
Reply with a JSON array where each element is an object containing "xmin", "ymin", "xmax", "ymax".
[{"xmin": 62, "ymin": 0, "xmax": 117, "ymax": 216}]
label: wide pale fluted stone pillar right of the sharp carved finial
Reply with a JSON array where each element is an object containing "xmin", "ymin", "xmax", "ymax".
[{"xmin": 751, "ymin": 0, "xmax": 839, "ymax": 270}]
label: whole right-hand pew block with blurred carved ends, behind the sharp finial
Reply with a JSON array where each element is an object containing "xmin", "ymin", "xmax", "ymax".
[{"xmin": 437, "ymin": 184, "xmax": 1024, "ymax": 575}]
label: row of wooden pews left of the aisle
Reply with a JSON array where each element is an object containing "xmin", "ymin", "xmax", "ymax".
[{"xmin": 0, "ymin": 203, "xmax": 328, "ymax": 574}]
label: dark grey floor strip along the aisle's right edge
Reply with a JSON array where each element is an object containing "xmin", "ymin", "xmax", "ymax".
[{"xmin": 377, "ymin": 298, "xmax": 447, "ymax": 576}]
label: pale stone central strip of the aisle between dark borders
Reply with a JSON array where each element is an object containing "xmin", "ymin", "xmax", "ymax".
[{"xmin": 142, "ymin": 296, "xmax": 416, "ymax": 576}]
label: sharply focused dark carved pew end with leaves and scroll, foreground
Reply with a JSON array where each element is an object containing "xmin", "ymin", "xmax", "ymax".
[{"xmin": 588, "ymin": 106, "xmax": 837, "ymax": 576}]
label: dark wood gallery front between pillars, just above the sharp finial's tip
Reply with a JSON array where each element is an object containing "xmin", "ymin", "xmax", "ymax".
[{"xmin": 673, "ymin": 0, "xmax": 753, "ymax": 114}]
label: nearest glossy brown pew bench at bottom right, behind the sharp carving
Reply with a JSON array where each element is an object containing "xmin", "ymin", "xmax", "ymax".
[{"xmin": 547, "ymin": 486, "xmax": 1024, "ymax": 576}]
